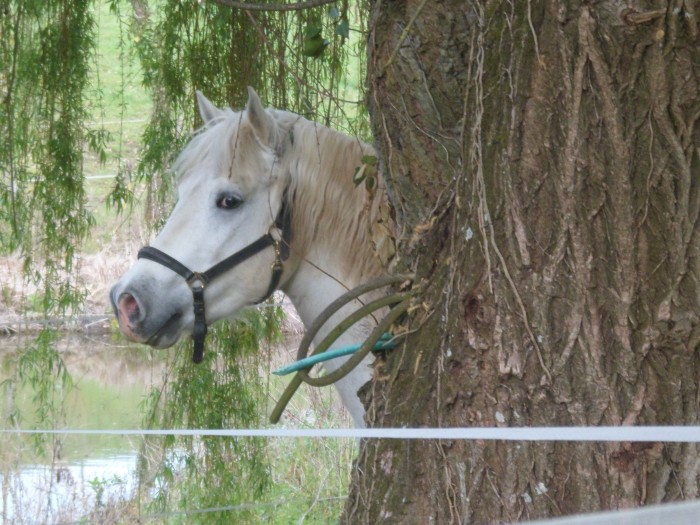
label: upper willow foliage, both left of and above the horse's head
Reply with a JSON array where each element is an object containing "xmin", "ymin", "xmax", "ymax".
[{"xmin": 0, "ymin": 0, "xmax": 367, "ymax": 302}]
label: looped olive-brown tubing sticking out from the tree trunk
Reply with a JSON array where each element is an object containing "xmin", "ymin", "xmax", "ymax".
[{"xmin": 270, "ymin": 274, "xmax": 418, "ymax": 423}]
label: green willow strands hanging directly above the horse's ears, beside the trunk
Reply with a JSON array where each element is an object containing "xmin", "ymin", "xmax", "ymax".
[{"xmin": 124, "ymin": 0, "xmax": 368, "ymax": 222}]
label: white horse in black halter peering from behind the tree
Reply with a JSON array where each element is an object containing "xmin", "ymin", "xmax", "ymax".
[{"xmin": 110, "ymin": 89, "xmax": 388, "ymax": 427}]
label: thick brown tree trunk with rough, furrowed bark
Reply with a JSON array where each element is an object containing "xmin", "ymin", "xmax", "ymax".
[{"xmin": 343, "ymin": 0, "xmax": 700, "ymax": 524}]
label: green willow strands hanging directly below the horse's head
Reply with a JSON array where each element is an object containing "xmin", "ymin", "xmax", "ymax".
[{"xmin": 139, "ymin": 308, "xmax": 283, "ymax": 524}]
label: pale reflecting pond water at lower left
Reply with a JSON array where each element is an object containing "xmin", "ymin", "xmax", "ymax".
[{"xmin": 0, "ymin": 336, "xmax": 163, "ymax": 524}]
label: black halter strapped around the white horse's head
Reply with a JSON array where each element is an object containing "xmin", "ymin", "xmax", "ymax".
[{"xmin": 138, "ymin": 196, "xmax": 292, "ymax": 363}]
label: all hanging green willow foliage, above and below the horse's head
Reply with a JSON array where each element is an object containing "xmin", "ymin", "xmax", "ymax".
[{"xmin": 0, "ymin": 0, "xmax": 369, "ymax": 522}]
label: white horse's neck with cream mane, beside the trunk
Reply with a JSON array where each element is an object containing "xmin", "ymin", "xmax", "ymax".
[{"xmin": 283, "ymin": 121, "xmax": 384, "ymax": 427}]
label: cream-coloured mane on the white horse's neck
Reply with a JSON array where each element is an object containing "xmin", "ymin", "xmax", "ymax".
[{"xmin": 269, "ymin": 110, "xmax": 391, "ymax": 285}]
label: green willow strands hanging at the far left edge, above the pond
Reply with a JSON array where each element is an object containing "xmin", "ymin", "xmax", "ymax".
[{"xmin": 0, "ymin": 0, "xmax": 106, "ymax": 311}]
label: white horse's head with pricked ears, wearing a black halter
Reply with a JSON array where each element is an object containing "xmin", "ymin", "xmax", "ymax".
[{"xmin": 110, "ymin": 89, "xmax": 294, "ymax": 352}]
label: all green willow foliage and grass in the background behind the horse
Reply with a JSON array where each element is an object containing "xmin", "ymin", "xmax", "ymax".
[{"xmin": 0, "ymin": 0, "xmax": 368, "ymax": 523}]
